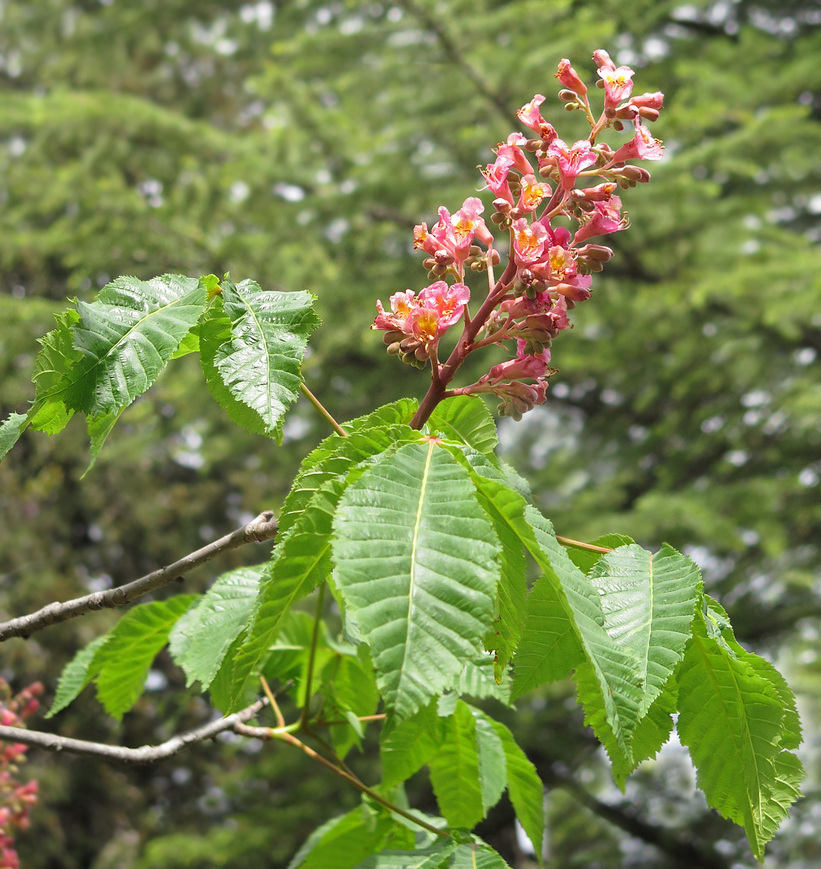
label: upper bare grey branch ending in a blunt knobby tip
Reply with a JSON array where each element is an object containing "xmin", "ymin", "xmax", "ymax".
[{"xmin": 0, "ymin": 511, "xmax": 277, "ymax": 642}]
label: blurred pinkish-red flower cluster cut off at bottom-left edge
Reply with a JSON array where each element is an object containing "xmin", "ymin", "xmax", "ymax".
[{"xmin": 0, "ymin": 679, "xmax": 44, "ymax": 869}]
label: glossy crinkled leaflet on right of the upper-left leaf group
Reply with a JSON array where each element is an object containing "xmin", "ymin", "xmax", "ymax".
[{"xmin": 213, "ymin": 279, "xmax": 320, "ymax": 440}]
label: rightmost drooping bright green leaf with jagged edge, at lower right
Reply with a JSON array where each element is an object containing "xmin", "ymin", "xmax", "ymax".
[{"xmin": 677, "ymin": 612, "xmax": 804, "ymax": 860}]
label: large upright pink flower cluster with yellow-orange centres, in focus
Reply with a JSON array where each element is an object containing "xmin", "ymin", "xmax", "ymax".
[{"xmin": 372, "ymin": 50, "xmax": 663, "ymax": 418}]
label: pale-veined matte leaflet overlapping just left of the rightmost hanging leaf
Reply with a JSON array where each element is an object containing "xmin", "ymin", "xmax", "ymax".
[{"xmin": 589, "ymin": 543, "xmax": 702, "ymax": 717}]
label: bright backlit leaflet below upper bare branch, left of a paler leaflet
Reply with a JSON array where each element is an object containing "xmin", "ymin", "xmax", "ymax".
[{"xmin": 90, "ymin": 594, "xmax": 196, "ymax": 719}]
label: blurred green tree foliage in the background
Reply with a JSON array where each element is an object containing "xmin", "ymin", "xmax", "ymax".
[{"xmin": 0, "ymin": 0, "xmax": 821, "ymax": 869}]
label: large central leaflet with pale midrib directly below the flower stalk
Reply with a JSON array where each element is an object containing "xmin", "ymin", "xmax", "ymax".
[{"xmin": 333, "ymin": 441, "xmax": 499, "ymax": 717}]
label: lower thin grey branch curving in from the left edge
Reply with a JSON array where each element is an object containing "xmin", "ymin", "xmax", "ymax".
[{"xmin": 0, "ymin": 698, "xmax": 268, "ymax": 763}]
